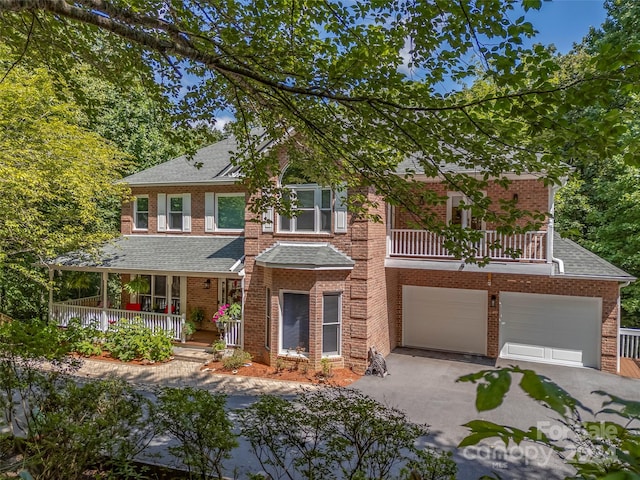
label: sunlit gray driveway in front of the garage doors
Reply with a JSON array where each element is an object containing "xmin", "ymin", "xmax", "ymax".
[{"xmin": 354, "ymin": 348, "xmax": 640, "ymax": 479}]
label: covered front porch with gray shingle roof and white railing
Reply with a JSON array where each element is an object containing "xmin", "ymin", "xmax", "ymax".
[{"xmin": 47, "ymin": 236, "xmax": 244, "ymax": 347}]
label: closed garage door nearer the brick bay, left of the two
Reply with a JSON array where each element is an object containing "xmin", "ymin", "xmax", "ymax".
[{"xmin": 402, "ymin": 285, "xmax": 487, "ymax": 355}]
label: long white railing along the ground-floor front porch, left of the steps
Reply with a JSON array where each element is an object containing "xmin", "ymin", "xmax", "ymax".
[{"xmin": 49, "ymin": 299, "xmax": 185, "ymax": 341}]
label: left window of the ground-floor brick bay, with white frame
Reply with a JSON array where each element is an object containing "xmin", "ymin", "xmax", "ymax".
[{"xmin": 280, "ymin": 292, "xmax": 309, "ymax": 354}]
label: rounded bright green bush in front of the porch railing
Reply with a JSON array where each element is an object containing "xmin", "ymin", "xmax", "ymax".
[{"xmin": 104, "ymin": 318, "xmax": 173, "ymax": 362}]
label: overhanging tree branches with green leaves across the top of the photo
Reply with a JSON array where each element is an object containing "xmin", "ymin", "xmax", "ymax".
[{"xmin": 0, "ymin": 0, "xmax": 640, "ymax": 255}]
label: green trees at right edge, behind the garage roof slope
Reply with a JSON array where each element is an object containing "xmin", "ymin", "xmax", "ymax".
[{"xmin": 556, "ymin": 0, "xmax": 640, "ymax": 327}]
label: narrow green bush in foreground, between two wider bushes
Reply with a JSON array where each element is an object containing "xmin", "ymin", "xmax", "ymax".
[{"xmin": 155, "ymin": 387, "xmax": 238, "ymax": 479}]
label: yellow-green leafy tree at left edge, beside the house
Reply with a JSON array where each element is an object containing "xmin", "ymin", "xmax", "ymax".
[{"xmin": 0, "ymin": 57, "xmax": 127, "ymax": 315}]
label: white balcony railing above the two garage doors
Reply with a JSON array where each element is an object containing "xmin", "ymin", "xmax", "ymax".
[{"xmin": 389, "ymin": 229, "xmax": 547, "ymax": 262}]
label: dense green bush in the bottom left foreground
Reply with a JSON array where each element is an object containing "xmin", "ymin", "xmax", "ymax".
[{"xmin": 25, "ymin": 373, "xmax": 155, "ymax": 479}]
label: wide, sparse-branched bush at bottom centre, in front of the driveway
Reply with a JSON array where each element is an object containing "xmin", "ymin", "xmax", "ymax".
[{"xmin": 239, "ymin": 388, "xmax": 456, "ymax": 480}]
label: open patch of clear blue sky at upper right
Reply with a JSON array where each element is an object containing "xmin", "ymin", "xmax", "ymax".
[{"xmin": 512, "ymin": 0, "xmax": 606, "ymax": 53}]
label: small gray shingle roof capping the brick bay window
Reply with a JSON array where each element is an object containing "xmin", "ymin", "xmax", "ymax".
[{"xmin": 256, "ymin": 243, "xmax": 355, "ymax": 270}]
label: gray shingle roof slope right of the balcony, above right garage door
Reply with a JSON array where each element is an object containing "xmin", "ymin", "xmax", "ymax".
[{"xmin": 553, "ymin": 233, "xmax": 635, "ymax": 281}]
